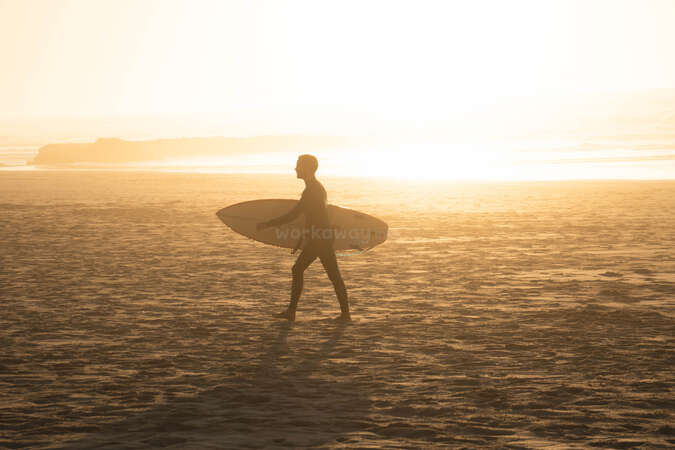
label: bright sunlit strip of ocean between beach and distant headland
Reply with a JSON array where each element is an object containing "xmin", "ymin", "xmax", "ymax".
[{"xmin": 0, "ymin": 131, "xmax": 675, "ymax": 181}]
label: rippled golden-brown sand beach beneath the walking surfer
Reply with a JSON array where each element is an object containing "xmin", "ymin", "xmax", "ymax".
[{"xmin": 0, "ymin": 171, "xmax": 675, "ymax": 448}]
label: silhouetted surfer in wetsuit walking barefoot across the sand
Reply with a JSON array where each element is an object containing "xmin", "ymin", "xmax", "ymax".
[{"xmin": 257, "ymin": 155, "xmax": 351, "ymax": 322}]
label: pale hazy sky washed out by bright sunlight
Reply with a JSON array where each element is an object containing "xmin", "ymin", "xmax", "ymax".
[{"xmin": 0, "ymin": 0, "xmax": 675, "ymax": 117}]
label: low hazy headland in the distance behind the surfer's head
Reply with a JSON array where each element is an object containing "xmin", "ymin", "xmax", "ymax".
[{"xmin": 32, "ymin": 136, "xmax": 348, "ymax": 165}]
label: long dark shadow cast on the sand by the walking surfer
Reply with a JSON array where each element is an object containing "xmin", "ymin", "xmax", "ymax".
[{"xmin": 67, "ymin": 322, "xmax": 372, "ymax": 448}]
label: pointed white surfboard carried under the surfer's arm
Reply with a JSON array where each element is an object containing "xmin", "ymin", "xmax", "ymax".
[{"xmin": 216, "ymin": 199, "xmax": 388, "ymax": 253}]
